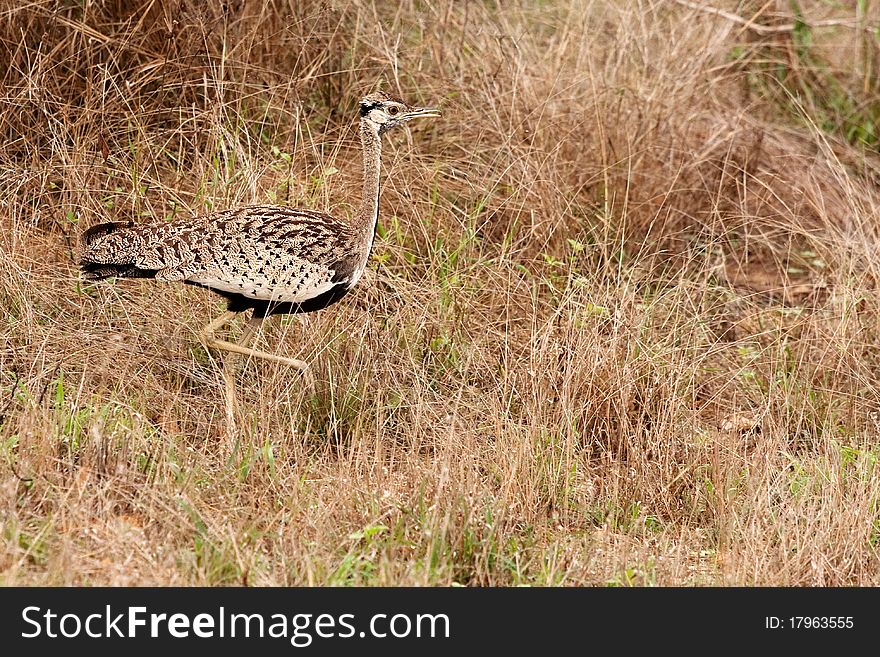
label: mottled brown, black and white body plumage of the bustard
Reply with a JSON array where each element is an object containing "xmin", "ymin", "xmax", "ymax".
[{"xmin": 82, "ymin": 205, "xmax": 366, "ymax": 317}]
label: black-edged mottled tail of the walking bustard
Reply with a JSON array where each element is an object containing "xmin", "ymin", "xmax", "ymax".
[{"xmin": 78, "ymin": 221, "xmax": 156, "ymax": 281}]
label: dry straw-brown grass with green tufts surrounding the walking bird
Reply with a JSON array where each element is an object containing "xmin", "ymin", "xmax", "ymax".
[{"xmin": 0, "ymin": 0, "xmax": 880, "ymax": 585}]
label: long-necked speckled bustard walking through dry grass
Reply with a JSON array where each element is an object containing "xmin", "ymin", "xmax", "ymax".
[{"xmin": 78, "ymin": 91, "xmax": 440, "ymax": 400}]
